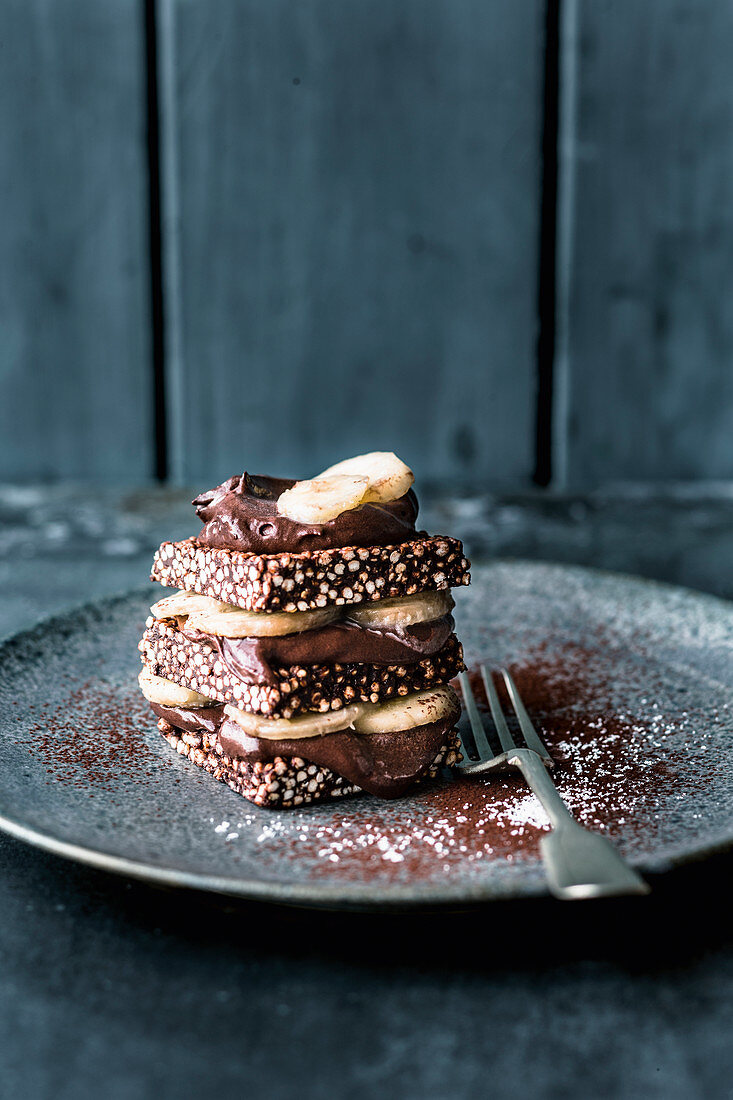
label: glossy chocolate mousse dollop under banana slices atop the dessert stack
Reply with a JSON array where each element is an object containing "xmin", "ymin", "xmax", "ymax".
[{"xmin": 193, "ymin": 473, "xmax": 426, "ymax": 553}]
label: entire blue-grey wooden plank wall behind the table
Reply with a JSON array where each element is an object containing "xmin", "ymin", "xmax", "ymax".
[{"xmin": 0, "ymin": 0, "xmax": 733, "ymax": 490}]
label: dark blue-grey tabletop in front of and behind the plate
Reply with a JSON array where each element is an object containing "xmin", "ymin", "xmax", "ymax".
[{"xmin": 0, "ymin": 486, "xmax": 733, "ymax": 1100}]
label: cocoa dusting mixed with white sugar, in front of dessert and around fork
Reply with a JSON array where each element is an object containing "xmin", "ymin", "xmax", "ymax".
[{"xmin": 201, "ymin": 637, "xmax": 709, "ymax": 881}]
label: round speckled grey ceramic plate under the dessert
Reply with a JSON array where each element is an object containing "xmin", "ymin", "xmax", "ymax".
[{"xmin": 0, "ymin": 562, "xmax": 733, "ymax": 908}]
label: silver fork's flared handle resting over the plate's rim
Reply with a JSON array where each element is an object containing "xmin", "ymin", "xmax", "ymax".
[{"xmin": 507, "ymin": 749, "xmax": 649, "ymax": 899}]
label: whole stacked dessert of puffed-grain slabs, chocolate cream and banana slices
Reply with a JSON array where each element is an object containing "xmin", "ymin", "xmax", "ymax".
[{"xmin": 139, "ymin": 452, "xmax": 470, "ymax": 809}]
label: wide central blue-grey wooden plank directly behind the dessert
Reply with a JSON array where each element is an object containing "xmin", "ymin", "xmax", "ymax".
[{"xmin": 158, "ymin": 0, "xmax": 543, "ymax": 484}]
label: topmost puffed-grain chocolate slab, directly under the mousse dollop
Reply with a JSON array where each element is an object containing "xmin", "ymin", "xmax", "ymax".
[{"xmin": 151, "ymin": 536, "xmax": 470, "ymax": 612}]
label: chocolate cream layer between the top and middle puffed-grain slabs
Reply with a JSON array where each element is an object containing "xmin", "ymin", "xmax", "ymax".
[{"xmin": 178, "ymin": 615, "xmax": 455, "ymax": 685}]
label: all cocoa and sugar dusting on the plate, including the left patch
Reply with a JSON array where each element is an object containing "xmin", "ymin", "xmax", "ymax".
[{"xmin": 15, "ymin": 634, "xmax": 718, "ymax": 882}]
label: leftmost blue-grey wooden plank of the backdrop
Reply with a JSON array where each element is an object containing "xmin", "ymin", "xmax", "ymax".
[{"xmin": 0, "ymin": 0, "xmax": 154, "ymax": 481}]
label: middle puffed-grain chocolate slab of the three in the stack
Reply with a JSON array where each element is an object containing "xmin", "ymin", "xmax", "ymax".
[{"xmin": 139, "ymin": 617, "xmax": 464, "ymax": 718}]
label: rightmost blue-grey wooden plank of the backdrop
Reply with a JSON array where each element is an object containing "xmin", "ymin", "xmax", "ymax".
[{"xmin": 556, "ymin": 0, "xmax": 733, "ymax": 485}]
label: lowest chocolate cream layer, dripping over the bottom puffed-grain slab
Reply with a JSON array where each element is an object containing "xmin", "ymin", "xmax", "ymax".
[{"xmin": 151, "ymin": 703, "xmax": 460, "ymax": 799}]
